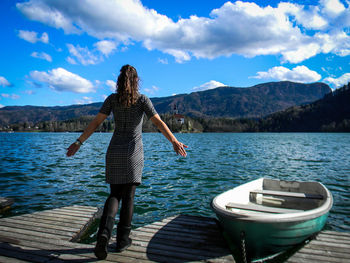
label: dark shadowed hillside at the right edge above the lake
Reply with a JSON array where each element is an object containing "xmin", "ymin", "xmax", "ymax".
[{"xmin": 259, "ymin": 83, "xmax": 350, "ymax": 132}]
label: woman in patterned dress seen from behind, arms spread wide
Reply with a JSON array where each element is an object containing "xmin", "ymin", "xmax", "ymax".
[{"xmin": 67, "ymin": 65, "xmax": 187, "ymax": 259}]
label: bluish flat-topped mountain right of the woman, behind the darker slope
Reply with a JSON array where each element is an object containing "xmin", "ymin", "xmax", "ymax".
[{"xmin": 152, "ymin": 81, "xmax": 331, "ymax": 118}]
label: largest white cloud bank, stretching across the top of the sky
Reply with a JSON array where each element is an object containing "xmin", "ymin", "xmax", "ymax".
[{"xmin": 16, "ymin": 0, "xmax": 350, "ymax": 64}]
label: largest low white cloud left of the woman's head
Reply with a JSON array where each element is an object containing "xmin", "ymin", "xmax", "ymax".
[{"xmin": 30, "ymin": 68, "xmax": 95, "ymax": 93}]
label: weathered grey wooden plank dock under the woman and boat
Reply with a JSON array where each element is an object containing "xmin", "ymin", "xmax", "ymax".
[{"xmin": 0, "ymin": 206, "xmax": 350, "ymax": 263}]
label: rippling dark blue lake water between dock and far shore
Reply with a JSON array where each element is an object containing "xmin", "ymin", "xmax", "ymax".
[{"xmin": 0, "ymin": 133, "xmax": 350, "ymax": 231}]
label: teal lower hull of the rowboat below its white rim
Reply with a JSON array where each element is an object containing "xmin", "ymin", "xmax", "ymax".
[{"xmin": 217, "ymin": 213, "xmax": 328, "ymax": 261}]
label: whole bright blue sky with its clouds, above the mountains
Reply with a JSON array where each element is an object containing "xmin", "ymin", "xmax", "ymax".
[{"xmin": 0, "ymin": 0, "xmax": 350, "ymax": 107}]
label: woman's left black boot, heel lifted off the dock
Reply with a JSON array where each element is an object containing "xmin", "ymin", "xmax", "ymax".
[{"xmin": 94, "ymin": 216, "xmax": 114, "ymax": 259}]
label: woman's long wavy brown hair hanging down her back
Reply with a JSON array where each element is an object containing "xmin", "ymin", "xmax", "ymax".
[{"xmin": 117, "ymin": 65, "xmax": 140, "ymax": 107}]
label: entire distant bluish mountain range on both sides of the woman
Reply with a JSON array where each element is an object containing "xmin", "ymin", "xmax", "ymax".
[{"xmin": 0, "ymin": 81, "xmax": 331, "ymax": 126}]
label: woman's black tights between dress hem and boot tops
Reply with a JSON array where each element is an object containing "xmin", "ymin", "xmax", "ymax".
[{"xmin": 103, "ymin": 184, "xmax": 138, "ymax": 227}]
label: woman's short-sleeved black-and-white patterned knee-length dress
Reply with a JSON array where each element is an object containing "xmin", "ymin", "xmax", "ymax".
[{"xmin": 100, "ymin": 93, "xmax": 157, "ymax": 184}]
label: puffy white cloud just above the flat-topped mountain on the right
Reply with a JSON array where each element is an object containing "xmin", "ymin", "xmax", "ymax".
[{"xmin": 253, "ymin": 66, "xmax": 321, "ymax": 83}]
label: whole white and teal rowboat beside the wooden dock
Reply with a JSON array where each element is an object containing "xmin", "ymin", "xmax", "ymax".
[{"xmin": 211, "ymin": 178, "xmax": 333, "ymax": 260}]
